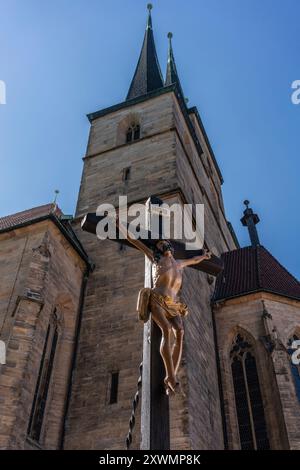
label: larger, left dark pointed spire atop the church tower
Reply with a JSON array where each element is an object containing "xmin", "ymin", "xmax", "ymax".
[{"xmin": 126, "ymin": 3, "xmax": 164, "ymax": 100}]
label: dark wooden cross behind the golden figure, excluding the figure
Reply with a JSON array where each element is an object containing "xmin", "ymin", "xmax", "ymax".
[{"xmin": 81, "ymin": 196, "xmax": 223, "ymax": 450}]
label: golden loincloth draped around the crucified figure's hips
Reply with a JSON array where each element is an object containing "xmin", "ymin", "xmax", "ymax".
[{"xmin": 137, "ymin": 287, "xmax": 188, "ymax": 322}]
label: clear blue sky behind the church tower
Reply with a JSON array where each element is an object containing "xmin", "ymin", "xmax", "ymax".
[{"xmin": 0, "ymin": 0, "xmax": 300, "ymax": 278}]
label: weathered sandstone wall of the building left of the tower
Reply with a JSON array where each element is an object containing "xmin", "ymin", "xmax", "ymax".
[{"xmin": 0, "ymin": 221, "xmax": 85, "ymax": 449}]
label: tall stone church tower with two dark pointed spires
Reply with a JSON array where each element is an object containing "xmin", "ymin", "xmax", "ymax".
[{"xmin": 64, "ymin": 6, "xmax": 237, "ymax": 449}]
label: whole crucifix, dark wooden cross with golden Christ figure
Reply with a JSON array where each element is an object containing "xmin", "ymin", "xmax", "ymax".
[{"xmin": 81, "ymin": 196, "xmax": 223, "ymax": 450}]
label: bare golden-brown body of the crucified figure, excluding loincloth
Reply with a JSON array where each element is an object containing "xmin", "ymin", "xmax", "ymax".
[{"xmin": 117, "ymin": 216, "xmax": 211, "ymax": 395}]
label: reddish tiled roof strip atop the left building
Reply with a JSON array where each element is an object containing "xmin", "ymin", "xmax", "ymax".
[{"xmin": 0, "ymin": 203, "xmax": 62, "ymax": 231}]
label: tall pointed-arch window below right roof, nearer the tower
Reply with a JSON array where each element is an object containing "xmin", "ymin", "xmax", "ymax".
[{"xmin": 230, "ymin": 334, "xmax": 270, "ymax": 450}]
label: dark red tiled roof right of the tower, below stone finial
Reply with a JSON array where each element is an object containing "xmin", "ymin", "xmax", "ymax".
[{"xmin": 213, "ymin": 246, "xmax": 300, "ymax": 301}]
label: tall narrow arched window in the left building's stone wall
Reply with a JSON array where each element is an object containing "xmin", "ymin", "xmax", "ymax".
[{"xmin": 27, "ymin": 309, "xmax": 59, "ymax": 442}]
